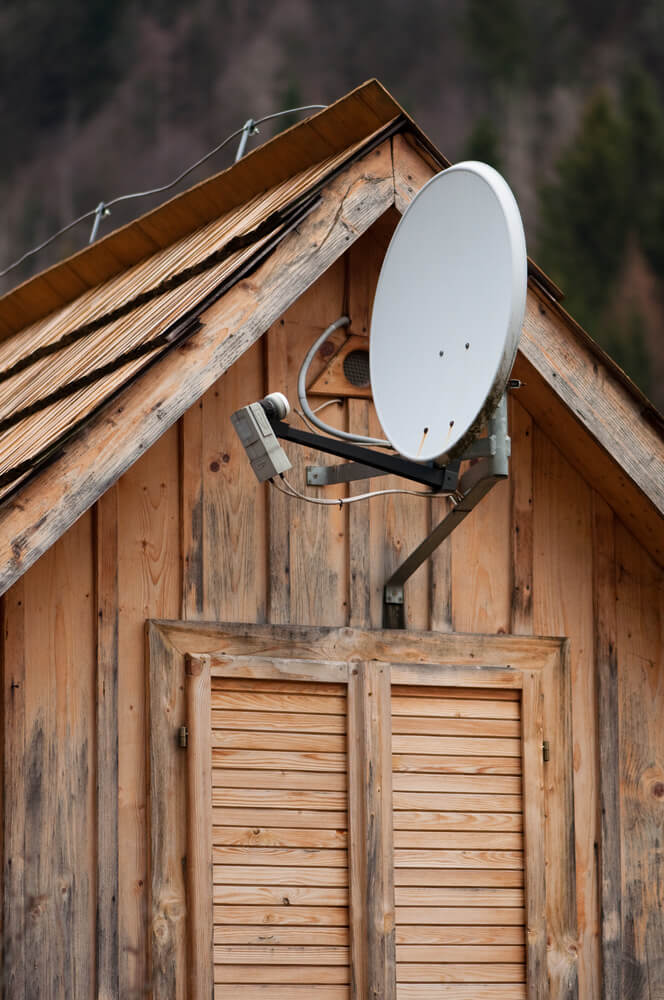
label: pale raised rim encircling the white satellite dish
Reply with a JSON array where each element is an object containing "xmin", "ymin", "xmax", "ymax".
[{"xmin": 369, "ymin": 160, "xmax": 528, "ymax": 462}]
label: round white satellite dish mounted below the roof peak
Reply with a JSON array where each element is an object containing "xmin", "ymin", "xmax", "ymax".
[{"xmin": 369, "ymin": 161, "xmax": 527, "ymax": 462}]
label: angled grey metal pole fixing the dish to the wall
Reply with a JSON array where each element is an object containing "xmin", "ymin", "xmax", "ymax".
[{"xmin": 383, "ymin": 395, "xmax": 510, "ymax": 628}]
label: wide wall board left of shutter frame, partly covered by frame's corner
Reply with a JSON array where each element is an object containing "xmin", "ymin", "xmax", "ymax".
[{"xmin": 118, "ymin": 428, "xmax": 179, "ymax": 995}]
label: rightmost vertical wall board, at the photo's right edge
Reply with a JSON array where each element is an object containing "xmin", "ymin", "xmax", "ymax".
[{"xmin": 615, "ymin": 521, "xmax": 664, "ymax": 1000}]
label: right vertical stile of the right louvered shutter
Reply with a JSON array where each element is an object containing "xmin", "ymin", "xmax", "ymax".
[{"xmin": 522, "ymin": 671, "xmax": 549, "ymax": 1000}]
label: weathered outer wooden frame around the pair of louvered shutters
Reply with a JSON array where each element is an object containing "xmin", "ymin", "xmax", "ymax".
[{"xmin": 147, "ymin": 621, "xmax": 578, "ymax": 1000}]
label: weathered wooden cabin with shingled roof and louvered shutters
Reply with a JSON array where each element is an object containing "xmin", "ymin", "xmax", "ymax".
[{"xmin": 0, "ymin": 81, "xmax": 664, "ymax": 1000}]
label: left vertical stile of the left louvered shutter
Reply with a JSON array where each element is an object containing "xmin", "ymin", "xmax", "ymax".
[{"xmin": 184, "ymin": 656, "xmax": 213, "ymax": 997}]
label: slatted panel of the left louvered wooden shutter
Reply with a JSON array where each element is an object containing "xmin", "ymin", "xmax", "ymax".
[{"xmin": 211, "ymin": 677, "xmax": 350, "ymax": 1000}]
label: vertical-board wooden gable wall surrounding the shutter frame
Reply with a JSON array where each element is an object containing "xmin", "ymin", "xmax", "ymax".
[{"xmin": 2, "ymin": 219, "xmax": 664, "ymax": 1000}]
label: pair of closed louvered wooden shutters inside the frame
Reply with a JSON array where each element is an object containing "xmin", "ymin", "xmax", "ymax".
[{"xmin": 148, "ymin": 629, "xmax": 572, "ymax": 1000}]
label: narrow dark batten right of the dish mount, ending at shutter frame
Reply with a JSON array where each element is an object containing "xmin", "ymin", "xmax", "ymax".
[{"xmin": 509, "ymin": 395, "xmax": 533, "ymax": 635}]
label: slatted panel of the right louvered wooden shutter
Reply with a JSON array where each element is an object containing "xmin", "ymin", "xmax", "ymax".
[{"xmin": 392, "ymin": 686, "xmax": 526, "ymax": 1000}]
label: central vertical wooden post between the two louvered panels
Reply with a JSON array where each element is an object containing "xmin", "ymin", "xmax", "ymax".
[{"xmin": 348, "ymin": 662, "xmax": 395, "ymax": 1000}]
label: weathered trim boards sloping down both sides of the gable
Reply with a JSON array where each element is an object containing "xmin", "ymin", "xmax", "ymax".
[{"xmin": 0, "ymin": 92, "xmax": 664, "ymax": 592}]
